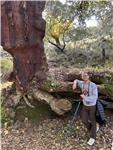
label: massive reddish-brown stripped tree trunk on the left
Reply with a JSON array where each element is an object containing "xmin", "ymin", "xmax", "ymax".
[{"xmin": 1, "ymin": 1, "xmax": 48, "ymax": 92}]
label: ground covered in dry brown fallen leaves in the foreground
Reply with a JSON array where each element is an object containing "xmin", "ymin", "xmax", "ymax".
[{"xmin": 1, "ymin": 111, "xmax": 113, "ymax": 150}]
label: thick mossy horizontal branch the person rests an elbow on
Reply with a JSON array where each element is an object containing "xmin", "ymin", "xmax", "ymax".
[{"xmin": 39, "ymin": 80, "xmax": 113, "ymax": 100}]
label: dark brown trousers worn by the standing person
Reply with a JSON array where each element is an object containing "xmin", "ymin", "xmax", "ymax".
[{"xmin": 81, "ymin": 105, "xmax": 96, "ymax": 139}]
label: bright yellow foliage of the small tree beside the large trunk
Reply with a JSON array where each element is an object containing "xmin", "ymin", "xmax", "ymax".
[{"xmin": 45, "ymin": 11, "xmax": 73, "ymax": 45}]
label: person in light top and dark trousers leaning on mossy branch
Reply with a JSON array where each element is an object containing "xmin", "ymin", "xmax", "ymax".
[{"xmin": 73, "ymin": 72, "xmax": 98, "ymax": 145}]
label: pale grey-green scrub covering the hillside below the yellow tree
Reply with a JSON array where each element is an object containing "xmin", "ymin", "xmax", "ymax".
[{"xmin": 46, "ymin": 35, "xmax": 113, "ymax": 70}]
